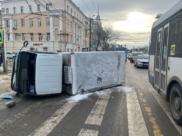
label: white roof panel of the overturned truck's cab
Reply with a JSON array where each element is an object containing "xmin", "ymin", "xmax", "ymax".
[{"xmin": 35, "ymin": 54, "xmax": 63, "ymax": 95}]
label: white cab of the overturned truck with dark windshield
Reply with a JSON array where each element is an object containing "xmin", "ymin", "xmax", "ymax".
[{"xmin": 11, "ymin": 51, "xmax": 63, "ymax": 95}]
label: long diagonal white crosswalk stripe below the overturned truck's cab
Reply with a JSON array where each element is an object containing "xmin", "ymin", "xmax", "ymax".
[{"xmin": 29, "ymin": 103, "xmax": 76, "ymax": 136}]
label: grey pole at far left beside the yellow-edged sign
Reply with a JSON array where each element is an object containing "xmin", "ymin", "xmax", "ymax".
[{"xmin": 0, "ymin": 5, "xmax": 6, "ymax": 73}]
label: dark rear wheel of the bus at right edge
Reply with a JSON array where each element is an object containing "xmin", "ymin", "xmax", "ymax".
[{"xmin": 169, "ymin": 84, "xmax": 182, "ymax": 126}]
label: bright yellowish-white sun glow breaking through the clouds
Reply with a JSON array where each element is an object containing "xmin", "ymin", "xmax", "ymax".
[{"xmin": 114, "ymin": 12, "xmax": 153, "ymax": 32}]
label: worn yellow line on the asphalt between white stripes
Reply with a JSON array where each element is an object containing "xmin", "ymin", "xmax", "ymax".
[{"xmin": 138, "ymin": 89, "xmax": 164, "ymax": 136}]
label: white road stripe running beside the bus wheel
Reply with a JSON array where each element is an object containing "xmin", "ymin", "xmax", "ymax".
[{"xmin": 149, "ymin": 89, "xmax": 182, "ymax": 135}]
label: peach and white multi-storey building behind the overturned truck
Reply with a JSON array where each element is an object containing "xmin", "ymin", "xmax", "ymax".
[{"xmin": 2, "ymin": 0, "xmax": 89, "ymax": 52}]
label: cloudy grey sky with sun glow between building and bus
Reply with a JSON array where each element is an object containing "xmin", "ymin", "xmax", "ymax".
[{"xmin": 72, "ymin": 0, "xmax": 179, "ymax": 47}]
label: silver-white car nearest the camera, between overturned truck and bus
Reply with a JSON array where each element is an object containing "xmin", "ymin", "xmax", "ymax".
[{"xmin": 134, "ymin": 54, "xmax": 149, "ymax": 68}]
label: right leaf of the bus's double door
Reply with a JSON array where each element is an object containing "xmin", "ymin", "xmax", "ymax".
[{"xmin": 159, "ymin": 24, "xmax": 169, "ymax": 94}]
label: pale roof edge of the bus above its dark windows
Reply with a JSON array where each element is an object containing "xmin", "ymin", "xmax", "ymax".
[{"xmin": 152, "ymin": 0, "xmax": 182, "ymax": 28}]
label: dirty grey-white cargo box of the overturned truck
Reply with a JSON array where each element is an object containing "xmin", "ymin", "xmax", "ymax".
[{"xmin": 62, "ymin": 51, "xmax": 125, "ymax": 95}]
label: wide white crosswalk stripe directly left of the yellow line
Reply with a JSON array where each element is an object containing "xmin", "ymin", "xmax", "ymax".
[{"xmin": 126, "ymin": 91, "xmax": 149, "ymax": 136}]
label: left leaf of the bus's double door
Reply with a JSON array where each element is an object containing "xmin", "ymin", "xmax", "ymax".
[{"xmin": 154, "ymin": 28, "xmax": 163, "ymax": 89}]
